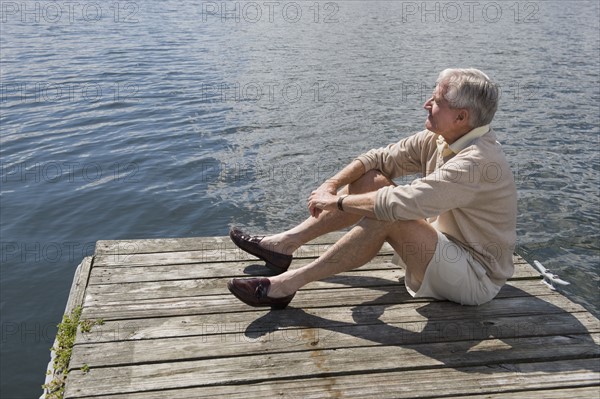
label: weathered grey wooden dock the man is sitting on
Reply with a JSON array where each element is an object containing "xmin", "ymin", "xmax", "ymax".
[{"xmin": 48, "ymin": 234, "xmax": 600, "ymax": 399}]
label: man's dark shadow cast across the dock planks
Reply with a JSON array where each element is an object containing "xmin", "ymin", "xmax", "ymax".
[{"xmin": 245, "ymin": 276, "xmax": 600, "ymax": 373}]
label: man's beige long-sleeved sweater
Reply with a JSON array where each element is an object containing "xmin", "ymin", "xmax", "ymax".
[{"xmin": 357, "ymin": 128, "xmax": 517, "ymax": 285}]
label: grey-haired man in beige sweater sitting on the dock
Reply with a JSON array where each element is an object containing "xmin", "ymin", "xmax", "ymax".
[{"xmin": 228, "ymin": 69, "xmax": 517, "ymax": 309}]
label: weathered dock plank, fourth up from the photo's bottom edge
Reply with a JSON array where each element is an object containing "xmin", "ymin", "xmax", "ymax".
[{"xmin": 76, "ymin": 297, "xmax": 600, "ymax": 344}]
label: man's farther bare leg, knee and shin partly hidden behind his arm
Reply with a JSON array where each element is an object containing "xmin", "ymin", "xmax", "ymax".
[{"xmin": 261, "ymin": 171, "xmax": 394, "ymax": 255}]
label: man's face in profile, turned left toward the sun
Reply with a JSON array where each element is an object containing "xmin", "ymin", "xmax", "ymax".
[{"xmin": 423, "ymin": 85, "xmax": 464, "ymax": 143}]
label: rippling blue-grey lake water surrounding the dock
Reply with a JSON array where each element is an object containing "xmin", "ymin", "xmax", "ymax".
[{"xmin": 0, "ymin": 0, "xmax": 600, "ymax": 399}]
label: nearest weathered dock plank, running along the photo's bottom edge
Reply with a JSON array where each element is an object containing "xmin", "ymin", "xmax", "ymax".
[{"xmin": 62, "ymin": 359, "xmax": 600, "ymax": 399}]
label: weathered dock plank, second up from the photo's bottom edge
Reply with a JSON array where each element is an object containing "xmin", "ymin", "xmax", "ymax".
[{"xmin": 65, "ymin": 334, "xmax": 600, "ymax": 397}]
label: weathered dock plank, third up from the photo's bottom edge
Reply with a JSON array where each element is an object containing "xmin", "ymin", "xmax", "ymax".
[{"xmin": 70, "ymin": 313, "xmax": 600, "ymax": 368}]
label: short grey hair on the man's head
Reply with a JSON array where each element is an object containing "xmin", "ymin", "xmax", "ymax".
[{"xmin": 436, "ymin": 68, "xmax": 499, "ymax": 128}]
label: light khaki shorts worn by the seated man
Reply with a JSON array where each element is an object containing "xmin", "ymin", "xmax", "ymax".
[{"xmin": 404, "ymin": 231, "xmax": 502, "ymax": 305}]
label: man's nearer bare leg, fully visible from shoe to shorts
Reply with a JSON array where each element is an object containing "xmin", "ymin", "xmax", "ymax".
[{"xmin": 268, "ymin": 218, "xmax": 437, "ymax": 298}]
